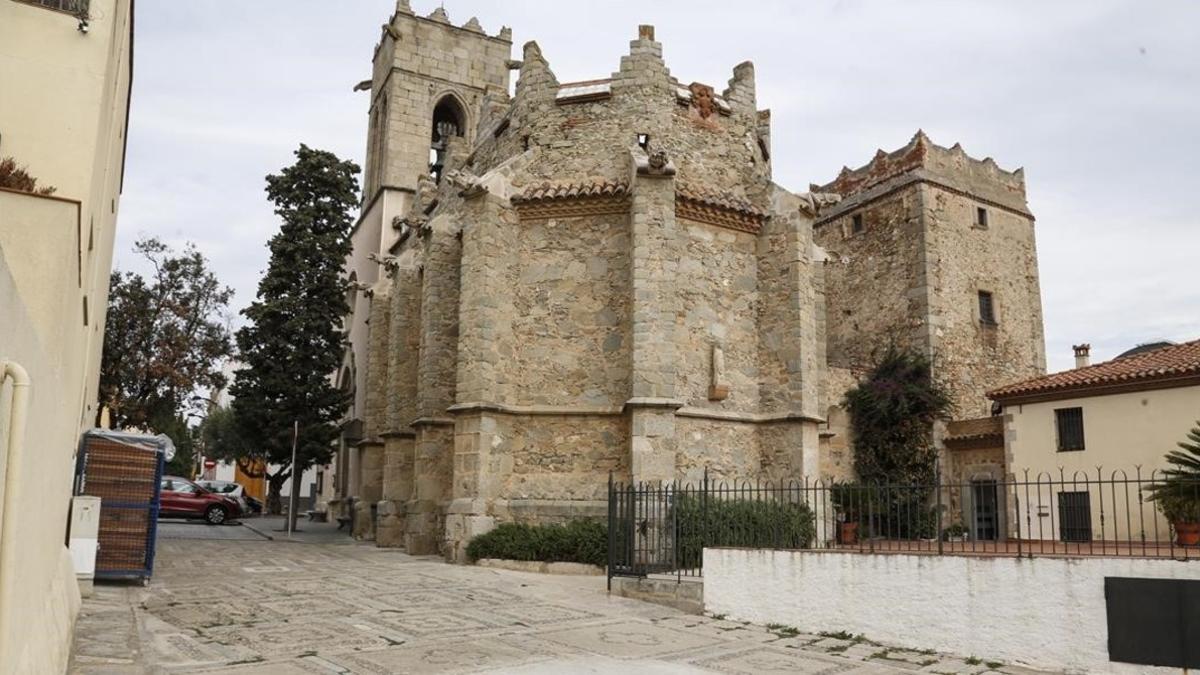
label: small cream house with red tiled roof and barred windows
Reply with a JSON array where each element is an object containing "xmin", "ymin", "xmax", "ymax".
[{"xmin": 989, "ymin": 340, "xmax": 1200, "ymax": 542}]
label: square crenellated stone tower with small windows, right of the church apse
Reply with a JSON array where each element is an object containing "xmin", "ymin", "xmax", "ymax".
[{"xmin": 812, "ymin": 131, "xmax": 1045, "ymax": 418}]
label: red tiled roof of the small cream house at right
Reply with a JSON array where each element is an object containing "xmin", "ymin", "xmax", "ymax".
[{"xmin": 988, "ymin": 340, "xmax": 1200, "ymax": 400}]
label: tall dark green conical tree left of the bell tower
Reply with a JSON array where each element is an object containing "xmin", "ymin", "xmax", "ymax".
[{"xmin": 230, "ymin": 144, "xmax": 359, "ymax": 518}]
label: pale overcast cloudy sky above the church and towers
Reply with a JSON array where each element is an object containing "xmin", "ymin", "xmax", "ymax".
[{"xmin": 116, "ymin": 0, "xmax": 1200, "ymax": 370}]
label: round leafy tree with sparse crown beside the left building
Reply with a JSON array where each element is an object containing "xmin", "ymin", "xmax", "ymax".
[{"xmin": 100, "ymin": 238, "xmax": 233, "ymax": 425}]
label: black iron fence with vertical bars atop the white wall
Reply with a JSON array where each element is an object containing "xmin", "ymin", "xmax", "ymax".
[{"xmin": 608, "ymin": 470, "xmax": 1200, "ymax": 578}]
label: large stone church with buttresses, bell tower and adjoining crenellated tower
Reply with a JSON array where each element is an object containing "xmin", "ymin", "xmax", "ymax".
[{"xmin": 325, "ymin": 0, "xmax": 1045, "ymax": 560}]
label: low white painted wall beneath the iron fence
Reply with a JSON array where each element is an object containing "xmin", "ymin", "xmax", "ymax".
[{"xmin": 704, "ymin": 549, "xmax": 1200, "ymax": 673}]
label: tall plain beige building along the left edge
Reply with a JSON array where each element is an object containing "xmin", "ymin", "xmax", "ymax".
[{"xmin": 0, "ymin": 0, "xmax": 133, "ymax": 673}]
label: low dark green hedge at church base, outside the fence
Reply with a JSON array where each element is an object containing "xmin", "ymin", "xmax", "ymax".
[{"xmin": 467, "ymin": 520, "xmax": 608, "ymax": 567}]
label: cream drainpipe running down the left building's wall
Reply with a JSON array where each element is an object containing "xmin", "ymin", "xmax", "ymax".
[{"xmin": 0, "ymin": 360, "xmax": 29, "ymax": 668}]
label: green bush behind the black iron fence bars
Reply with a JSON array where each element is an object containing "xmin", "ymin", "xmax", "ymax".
[{"xmin": 676, "ymin": 495, "xmax": 816, "ymax": 568}]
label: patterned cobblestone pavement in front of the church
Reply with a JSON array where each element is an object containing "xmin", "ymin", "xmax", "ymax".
[{"xmin": 71, "ymin": 535, "xmax": 1051, "ymax": 675}]
